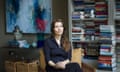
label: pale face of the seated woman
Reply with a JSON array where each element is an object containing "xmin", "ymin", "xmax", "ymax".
[{"xmin": 54, "ymin": 22, "xmax": 64, "ymax": 36}]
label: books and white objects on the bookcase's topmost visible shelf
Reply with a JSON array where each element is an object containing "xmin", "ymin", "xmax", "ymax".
[{"xmin": 72, "ymin": 2, "xmax": 108, "ymax": 19}]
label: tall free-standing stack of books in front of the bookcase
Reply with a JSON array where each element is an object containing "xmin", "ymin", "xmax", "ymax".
[{"xmin": 98, "ymin": 25, "xmax": 116, "ymax": 71}]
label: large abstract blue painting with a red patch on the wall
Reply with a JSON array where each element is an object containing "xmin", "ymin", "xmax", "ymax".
[{"xmin": 6, "ymin": 0, "xmax": 52, "ymax": 33}]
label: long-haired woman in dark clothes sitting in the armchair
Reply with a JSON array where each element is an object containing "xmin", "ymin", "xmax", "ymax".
[{"xmin": 43, "ymin": 19, "xmax": 82, "ymax": 72}]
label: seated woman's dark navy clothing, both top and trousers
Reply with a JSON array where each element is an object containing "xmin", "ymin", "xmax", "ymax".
[{"xmin": 43, "ymin": 37, "xmax": 82, "ymax": 72}]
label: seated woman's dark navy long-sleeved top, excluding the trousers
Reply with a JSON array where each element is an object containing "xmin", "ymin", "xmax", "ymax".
[{"xmin": 43, "ymin": 37, "xmax": 71, "ymax": 63}]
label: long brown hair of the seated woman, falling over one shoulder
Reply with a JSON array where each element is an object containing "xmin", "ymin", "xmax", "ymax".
[{"xmin": 51, "ymin": 19, "xmax": 71, "ymax": 51}]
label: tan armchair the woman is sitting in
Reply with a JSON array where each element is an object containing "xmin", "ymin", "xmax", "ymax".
[{"xmin": 40, "ymin": 48, "xmax": 96, "ymax": 72}]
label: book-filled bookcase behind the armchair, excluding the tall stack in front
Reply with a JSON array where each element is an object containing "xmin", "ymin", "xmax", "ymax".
[{"xmin": 68, "ymin": 0, "xmax": 109, "ymax": 59}]
